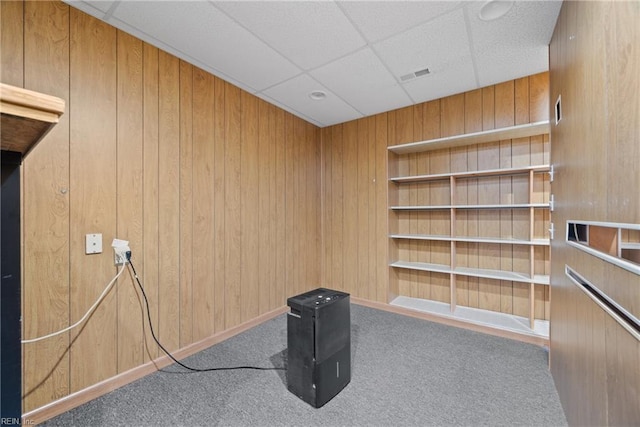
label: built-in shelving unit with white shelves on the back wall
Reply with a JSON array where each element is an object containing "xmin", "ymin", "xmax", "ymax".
[{"xmin": 388, "ymin": 121, "xmax": 551, "ymax": 338}]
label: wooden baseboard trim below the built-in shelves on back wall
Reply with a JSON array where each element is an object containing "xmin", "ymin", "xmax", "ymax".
[{"xmin": 351, "ymin": 297, "xmax": 549, "ymax": 347}]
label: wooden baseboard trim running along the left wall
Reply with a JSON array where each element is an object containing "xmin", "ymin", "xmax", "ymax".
[{"xmin": 22, "ymin": 306, "xmax": 288, "ymax": 425}]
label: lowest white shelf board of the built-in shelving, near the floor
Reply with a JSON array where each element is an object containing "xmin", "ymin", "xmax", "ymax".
[{"xmin": 389, "ymin": 296, "xmax": 549, "ymax": 339}]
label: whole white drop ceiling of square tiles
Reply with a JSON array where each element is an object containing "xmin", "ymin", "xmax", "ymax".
[{"xmin": 62, "ymin": 0, "xmax": 561, "ymax": 127}]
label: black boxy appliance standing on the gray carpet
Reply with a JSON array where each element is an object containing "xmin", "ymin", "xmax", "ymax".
[{"xmin": 287, "ymin": 288, "xmax": 351, "ymax": 408}]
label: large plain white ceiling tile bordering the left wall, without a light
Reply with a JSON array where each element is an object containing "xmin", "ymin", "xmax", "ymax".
[{"xmin": 114, "ymin": 1, "xmax": 300, "ymax": 91}]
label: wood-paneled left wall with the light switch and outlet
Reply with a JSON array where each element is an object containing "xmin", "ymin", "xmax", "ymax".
[{"xmin": 0, "ymin": 1, "xmax": 321, "ymax": 412}]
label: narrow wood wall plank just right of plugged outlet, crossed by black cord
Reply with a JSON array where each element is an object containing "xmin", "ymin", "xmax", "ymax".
[{"xmin": 142, "ymin": 43, "xmax": 160, "ymax": 360}]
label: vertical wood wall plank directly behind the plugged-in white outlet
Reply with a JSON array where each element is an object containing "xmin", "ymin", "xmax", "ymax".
[{"xmin": 116, "ymin": 31, "xmax": 145, "ymax": 372}]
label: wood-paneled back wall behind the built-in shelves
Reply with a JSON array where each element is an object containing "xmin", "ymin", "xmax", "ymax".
[{"xmin": 321, "ymin": 73, "xmax": 549, "ymax": 319}]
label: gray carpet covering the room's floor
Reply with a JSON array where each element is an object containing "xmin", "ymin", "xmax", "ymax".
[{"xmin": 44, "ymin": 304, "xmax": 567, "ymax": 427}]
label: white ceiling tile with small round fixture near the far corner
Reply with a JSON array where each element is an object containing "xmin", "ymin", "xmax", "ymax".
[{"xmin": 262, "ymin": 74, "xmax": 362, "ymax": 126}]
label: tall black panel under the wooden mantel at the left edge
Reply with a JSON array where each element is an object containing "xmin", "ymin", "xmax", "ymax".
[{"xmin": 0, "ymin": 151, "xmax": 22, "ymax": 424}]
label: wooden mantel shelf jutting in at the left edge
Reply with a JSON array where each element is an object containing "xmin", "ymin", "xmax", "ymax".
[{"xmin": 0, "ymin": 83, "xmax": 65, "ymax": 156}]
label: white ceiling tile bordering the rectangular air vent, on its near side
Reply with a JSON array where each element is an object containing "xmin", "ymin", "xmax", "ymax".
[{"xmin": 374, "ymin": 9, "xmax": 471, "ymax": 78}]
